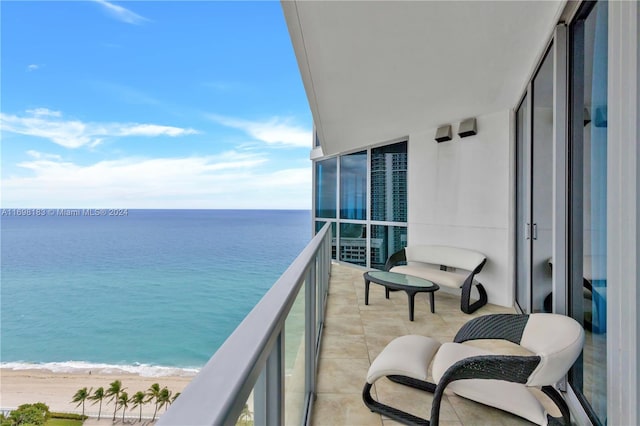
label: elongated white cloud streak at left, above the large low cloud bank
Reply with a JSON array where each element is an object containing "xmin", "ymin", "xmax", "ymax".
[{"xmin": 0, "ymin": 108, "xmax": 198, "ymax": 148}]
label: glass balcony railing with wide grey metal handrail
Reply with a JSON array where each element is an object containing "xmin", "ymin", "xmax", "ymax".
[{"xmin": 157, "ymin": 224, "xmax": 331, "ymax": 426}]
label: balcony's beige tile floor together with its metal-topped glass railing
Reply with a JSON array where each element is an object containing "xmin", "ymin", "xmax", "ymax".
[{"xmin": 158, "ymin": 224, "xmax": 559, "ymax": 426}]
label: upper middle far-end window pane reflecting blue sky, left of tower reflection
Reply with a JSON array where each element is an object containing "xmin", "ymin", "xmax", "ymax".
[{"xmin": 340, "ymin": 151, "xmax": 367, "ymax": 220}]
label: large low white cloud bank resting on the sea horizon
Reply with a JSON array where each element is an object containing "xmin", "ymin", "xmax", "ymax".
[{"xmin": 2, "ymin": 151, "xmax": 311, "ymax": 209}]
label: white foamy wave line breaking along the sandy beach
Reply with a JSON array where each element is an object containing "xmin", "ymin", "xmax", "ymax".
[{"xmin": 0, "ymin": 361, "xmax": 200, "ymax": 377}]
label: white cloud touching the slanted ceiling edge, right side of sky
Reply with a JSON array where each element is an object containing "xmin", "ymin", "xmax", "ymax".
[{"xmin": 209, "ymin": 114, "xmax": 312, "ymax": 148}]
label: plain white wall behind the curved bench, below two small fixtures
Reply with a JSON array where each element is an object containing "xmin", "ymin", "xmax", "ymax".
[{"xmin": 407, "ymin": 110, "xmax": 514, "ymax": 306}]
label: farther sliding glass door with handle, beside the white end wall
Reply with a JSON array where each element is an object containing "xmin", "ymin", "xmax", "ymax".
[{"xmin": 516, "ymin": 46, "xmax": 554, "ymax": 312}]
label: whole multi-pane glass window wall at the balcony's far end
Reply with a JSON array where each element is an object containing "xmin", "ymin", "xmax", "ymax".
[{"xmin": 314, "ymin": 141, "xmax": 407, "ymax": 269}]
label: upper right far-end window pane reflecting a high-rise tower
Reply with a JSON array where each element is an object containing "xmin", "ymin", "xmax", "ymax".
[{"xmin": 371, "ymin": 142, "xmax": 407, "ymax": 222}]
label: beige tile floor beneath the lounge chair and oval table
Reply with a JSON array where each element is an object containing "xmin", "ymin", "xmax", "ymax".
[{"xmin": 312, "ymin": 264, "xmax": 553, "ymax": 426}]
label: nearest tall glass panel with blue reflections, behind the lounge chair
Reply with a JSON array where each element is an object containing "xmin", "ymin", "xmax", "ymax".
[{"xmin": 569, "ymin": 1, "xmax": 608, "ymax": 424}]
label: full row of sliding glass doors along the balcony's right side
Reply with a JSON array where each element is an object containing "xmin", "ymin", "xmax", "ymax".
[{"xmin": 515, "ymin": 1, "xmax": 609, "ymax": 425}]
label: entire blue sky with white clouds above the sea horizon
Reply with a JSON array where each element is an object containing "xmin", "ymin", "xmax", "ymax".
[{"xmin": 0, "ymin": 0, "xmax": 312, "ymax": 209}]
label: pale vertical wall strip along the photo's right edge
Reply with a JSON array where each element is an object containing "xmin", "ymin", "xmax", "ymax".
[{"xmin": 607, "ymin": 1, "xmax": 640, "ymax": 425}]
